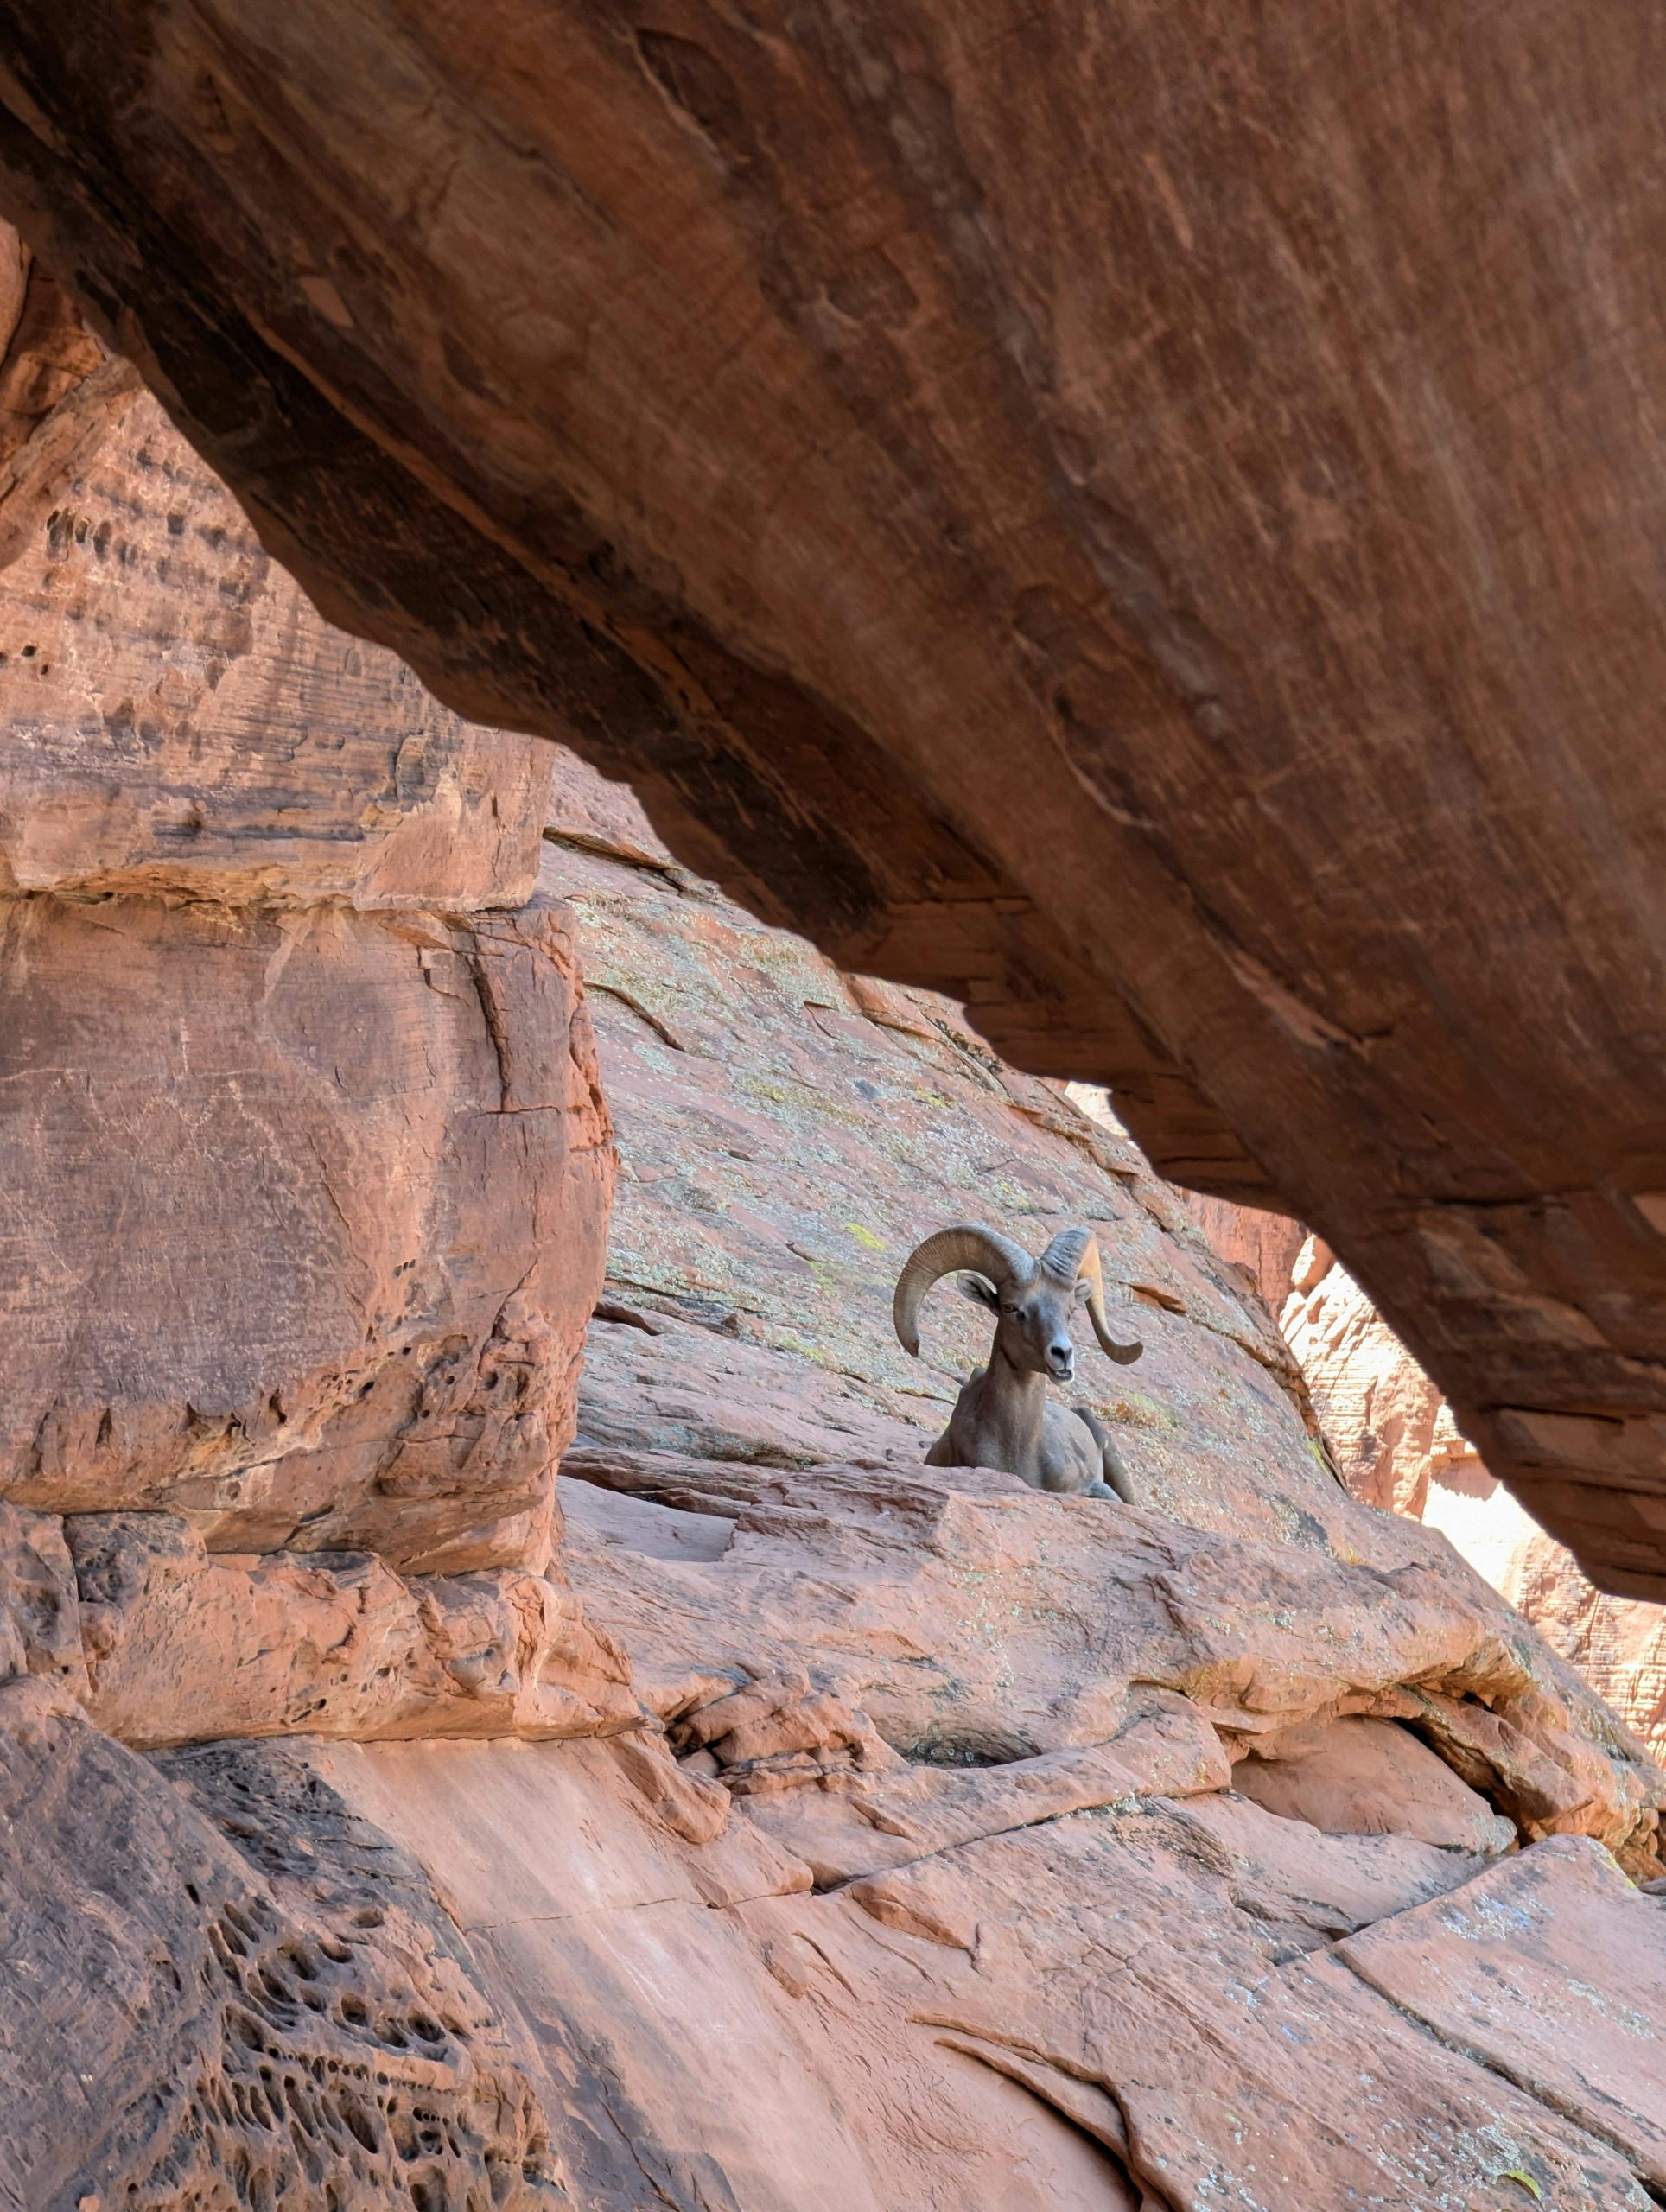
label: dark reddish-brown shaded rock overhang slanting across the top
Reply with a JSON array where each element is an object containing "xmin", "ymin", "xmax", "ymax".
[{"xmin": 0, "ymin": 0, "xmax": 1666, "ymax": 1597}]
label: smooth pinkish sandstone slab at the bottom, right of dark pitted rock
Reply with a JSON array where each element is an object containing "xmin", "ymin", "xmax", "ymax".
[{"xmin": 312, "ymin": 1745, "xmax": 1653, "ymax": 2212}]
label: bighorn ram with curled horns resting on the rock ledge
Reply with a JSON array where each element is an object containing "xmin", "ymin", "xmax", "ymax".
[{"xmin": 892, "ymin": 1224, "xmax": 1146, "ymax": 1504}]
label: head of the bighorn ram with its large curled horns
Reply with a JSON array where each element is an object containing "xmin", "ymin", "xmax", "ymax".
[{"xmin": 892, "ymin": 1224, "xmax": 1144, "ymax": 1382}]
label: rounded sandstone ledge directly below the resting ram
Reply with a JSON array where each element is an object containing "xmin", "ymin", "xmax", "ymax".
[{"xmin": 562, "ymin": 1451, "xmax": 1666, "ymax": 1873}]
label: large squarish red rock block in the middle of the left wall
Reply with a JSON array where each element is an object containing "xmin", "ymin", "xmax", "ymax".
[{"xmin": 0, "ymin": 896, "xmax": 613, "ymax": 1573}]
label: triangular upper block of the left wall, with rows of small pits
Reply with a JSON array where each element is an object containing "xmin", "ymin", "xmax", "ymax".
[{"xmin": 0, "ymin": 372, "xmax": 546, "ymax": 909}]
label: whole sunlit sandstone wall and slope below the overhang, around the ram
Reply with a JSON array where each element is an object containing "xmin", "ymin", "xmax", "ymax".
[{"xmin": 0, "ymin": 353, "xmax": 1666, "ymax": 2212}]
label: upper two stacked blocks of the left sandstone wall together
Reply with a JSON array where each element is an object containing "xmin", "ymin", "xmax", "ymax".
[{"xmin": 0, "ymin": 400, "xmax": 611, "ymax": 1571}]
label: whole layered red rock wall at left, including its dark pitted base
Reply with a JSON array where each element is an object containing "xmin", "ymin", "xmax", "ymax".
[{"xmin": 0, "ymin": 358, "xmax": 642, "ymax": 2212}]
